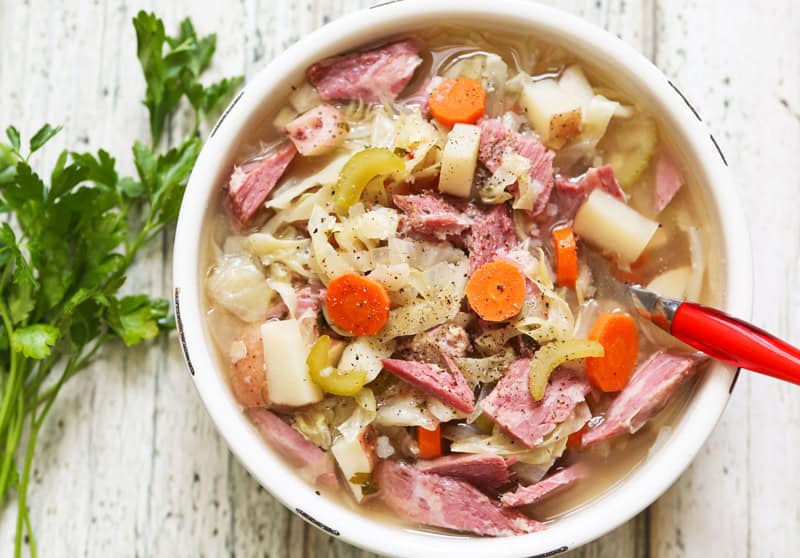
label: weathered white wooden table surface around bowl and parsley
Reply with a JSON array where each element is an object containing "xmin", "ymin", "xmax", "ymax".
[{"xmin": 0, "ymin": 0, "xmax": 800, "ymax": 558}]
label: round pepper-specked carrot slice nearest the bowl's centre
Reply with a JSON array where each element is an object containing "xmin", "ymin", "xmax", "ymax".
[{"xmin": 467, "ymin": 262, "xmax": 525, "ymax": 322}]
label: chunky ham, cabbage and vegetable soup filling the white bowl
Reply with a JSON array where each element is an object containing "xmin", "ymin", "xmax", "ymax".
[{"xmin": 206, "ymin": 27, "xmax": 718, "ymax": 536}]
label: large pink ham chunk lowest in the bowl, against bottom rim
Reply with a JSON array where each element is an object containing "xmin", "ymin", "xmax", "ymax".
[{"xmin": 375, "ymin": 461, "xmax": 545, "ymax": 537}]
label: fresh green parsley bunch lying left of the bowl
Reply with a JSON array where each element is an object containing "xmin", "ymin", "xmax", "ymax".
[{"xmin": 0, "ymin": 12, "xmax": 242, "ymax": 557}]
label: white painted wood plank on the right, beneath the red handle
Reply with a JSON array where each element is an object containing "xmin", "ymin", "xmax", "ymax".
[{"xmin": 652, "ymin": 0, "xmax": 800, "ymax": 557}]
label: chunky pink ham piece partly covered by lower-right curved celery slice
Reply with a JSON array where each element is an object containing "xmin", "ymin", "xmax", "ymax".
[{"xmin": 481, "ymin": 364, "xmax": 591, "ymax": 448}]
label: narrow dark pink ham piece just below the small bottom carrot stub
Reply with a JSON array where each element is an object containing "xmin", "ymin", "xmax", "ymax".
[{"xmin": 417, "ymin": 453, "xmax": 511, "ymax": 490}]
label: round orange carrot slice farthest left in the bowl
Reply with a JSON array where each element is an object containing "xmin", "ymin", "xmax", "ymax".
[{"xmin": 325, "ymin": 273, "xmax": 390, "ymax": 335}]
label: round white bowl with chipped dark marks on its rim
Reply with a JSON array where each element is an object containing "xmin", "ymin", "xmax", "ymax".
[{"xmin": 173, "ymin": 0, "xmax": 752, "ymax": 558}]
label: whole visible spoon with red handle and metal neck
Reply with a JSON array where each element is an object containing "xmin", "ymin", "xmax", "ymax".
[{"xmin": 628, "ymin": 285, "xmax": 800, "ymax": 385}]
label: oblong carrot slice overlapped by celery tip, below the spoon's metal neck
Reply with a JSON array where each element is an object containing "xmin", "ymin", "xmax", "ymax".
[{"xmin": 585, "ymin": 312, "xmax": 639, "ymax": 392}]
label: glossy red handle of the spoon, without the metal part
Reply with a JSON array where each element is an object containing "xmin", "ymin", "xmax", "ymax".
[{"xmin": 672, "ymin": 302, "xmax": 800, "ymax": 384}]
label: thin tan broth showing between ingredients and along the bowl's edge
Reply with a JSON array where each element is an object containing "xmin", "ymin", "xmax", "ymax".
[{"xmin": 198, "ymin": 27, "xmax": 722, "ymax": 536}]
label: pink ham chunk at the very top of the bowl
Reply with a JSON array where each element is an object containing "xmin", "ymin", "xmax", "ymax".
[{"xmin": 307, "ymin": 41, "xmax": 422, "ymax": 103}]
